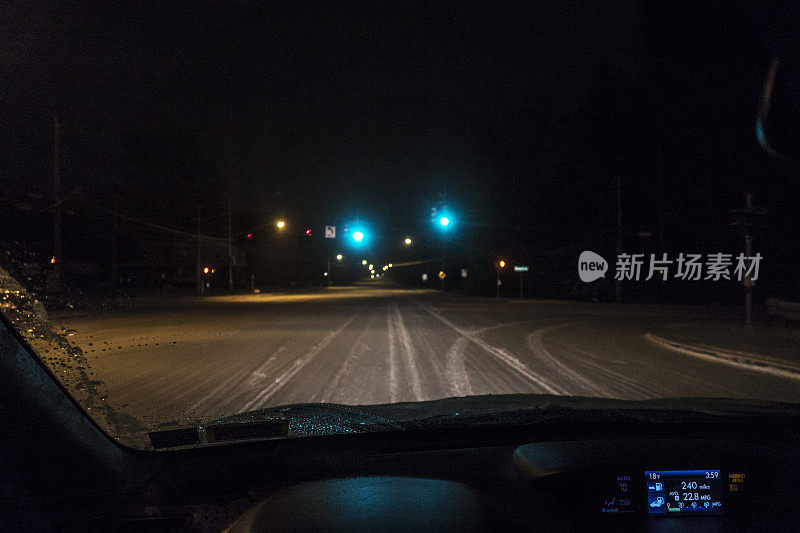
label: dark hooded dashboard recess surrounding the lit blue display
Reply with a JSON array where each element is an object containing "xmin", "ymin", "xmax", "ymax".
[{"xmin": 514, "ymin": 439, "xmax": 798, "ymax": 530}]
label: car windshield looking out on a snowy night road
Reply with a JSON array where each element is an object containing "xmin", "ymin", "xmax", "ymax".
[{"xmin": 0, "ymin": 1, "xmax": 800, "ymax": 448}]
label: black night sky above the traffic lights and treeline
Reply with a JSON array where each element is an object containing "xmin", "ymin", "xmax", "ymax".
[{"xmin": 0, "ymin": 0, "xmax": 798, "ymax": 290}]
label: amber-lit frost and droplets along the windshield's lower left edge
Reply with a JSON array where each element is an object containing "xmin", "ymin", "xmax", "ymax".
[{"xmin": 0, "ymin": 268, "xmax": 146, "ymax": 447}]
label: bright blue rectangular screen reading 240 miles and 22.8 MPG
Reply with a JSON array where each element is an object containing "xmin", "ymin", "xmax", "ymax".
[{"xmin": 644, "ymin": 470, "xmax": 723, "ymax": 515}]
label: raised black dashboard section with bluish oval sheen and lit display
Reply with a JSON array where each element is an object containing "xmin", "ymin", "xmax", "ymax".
[{"xmin": 222, "ymin": 439, "xmax": 800, "ymax": 532}]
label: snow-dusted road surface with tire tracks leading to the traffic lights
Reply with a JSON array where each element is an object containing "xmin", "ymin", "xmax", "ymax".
[{"xmin": 53, "ymin": 285, "xmax": 800, "ymax": 422}]
